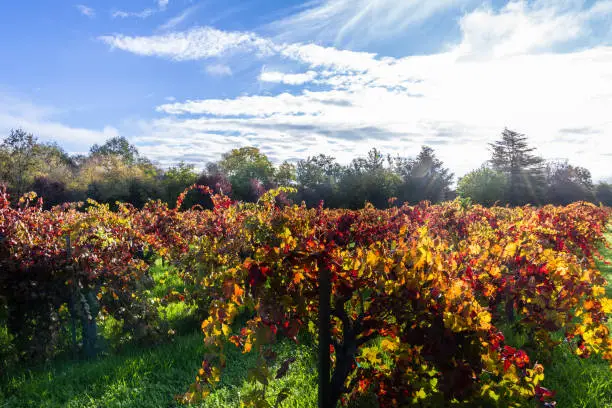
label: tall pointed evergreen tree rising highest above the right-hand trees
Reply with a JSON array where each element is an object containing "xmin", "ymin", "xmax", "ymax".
[{"xmin": 490, "ymin": 128, "xmax": 544, "ymax": 205}]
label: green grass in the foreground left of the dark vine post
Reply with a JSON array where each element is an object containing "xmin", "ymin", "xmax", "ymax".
[{"xmin": 0, "ymin": 333, "xmax": 317, "ymax": 408}]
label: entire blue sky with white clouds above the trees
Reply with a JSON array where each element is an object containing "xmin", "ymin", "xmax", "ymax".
[{"xmin": 0, "ymin": 0, "xmax": 612, "ymax": 179}]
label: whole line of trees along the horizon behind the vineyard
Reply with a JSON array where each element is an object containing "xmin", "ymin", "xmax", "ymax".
[{"xmin": 0, "ymin": 129, "xmax": 612, "ymax": 208}]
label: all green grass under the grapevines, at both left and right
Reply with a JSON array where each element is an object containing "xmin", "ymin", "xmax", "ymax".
[{"xmin": 0, "ymin": 231, "xmax": 612, "ymax": 408}]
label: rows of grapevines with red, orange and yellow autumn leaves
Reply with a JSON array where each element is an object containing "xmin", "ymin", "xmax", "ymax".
[{"xmin": 0, "ymin": 186, "xmax": 612, "ymax": 407}]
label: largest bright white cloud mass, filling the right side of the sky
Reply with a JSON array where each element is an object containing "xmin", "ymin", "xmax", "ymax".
[{"xmin": 103, "ymin": 0, "xmax": 612, "ymax": 179}]
